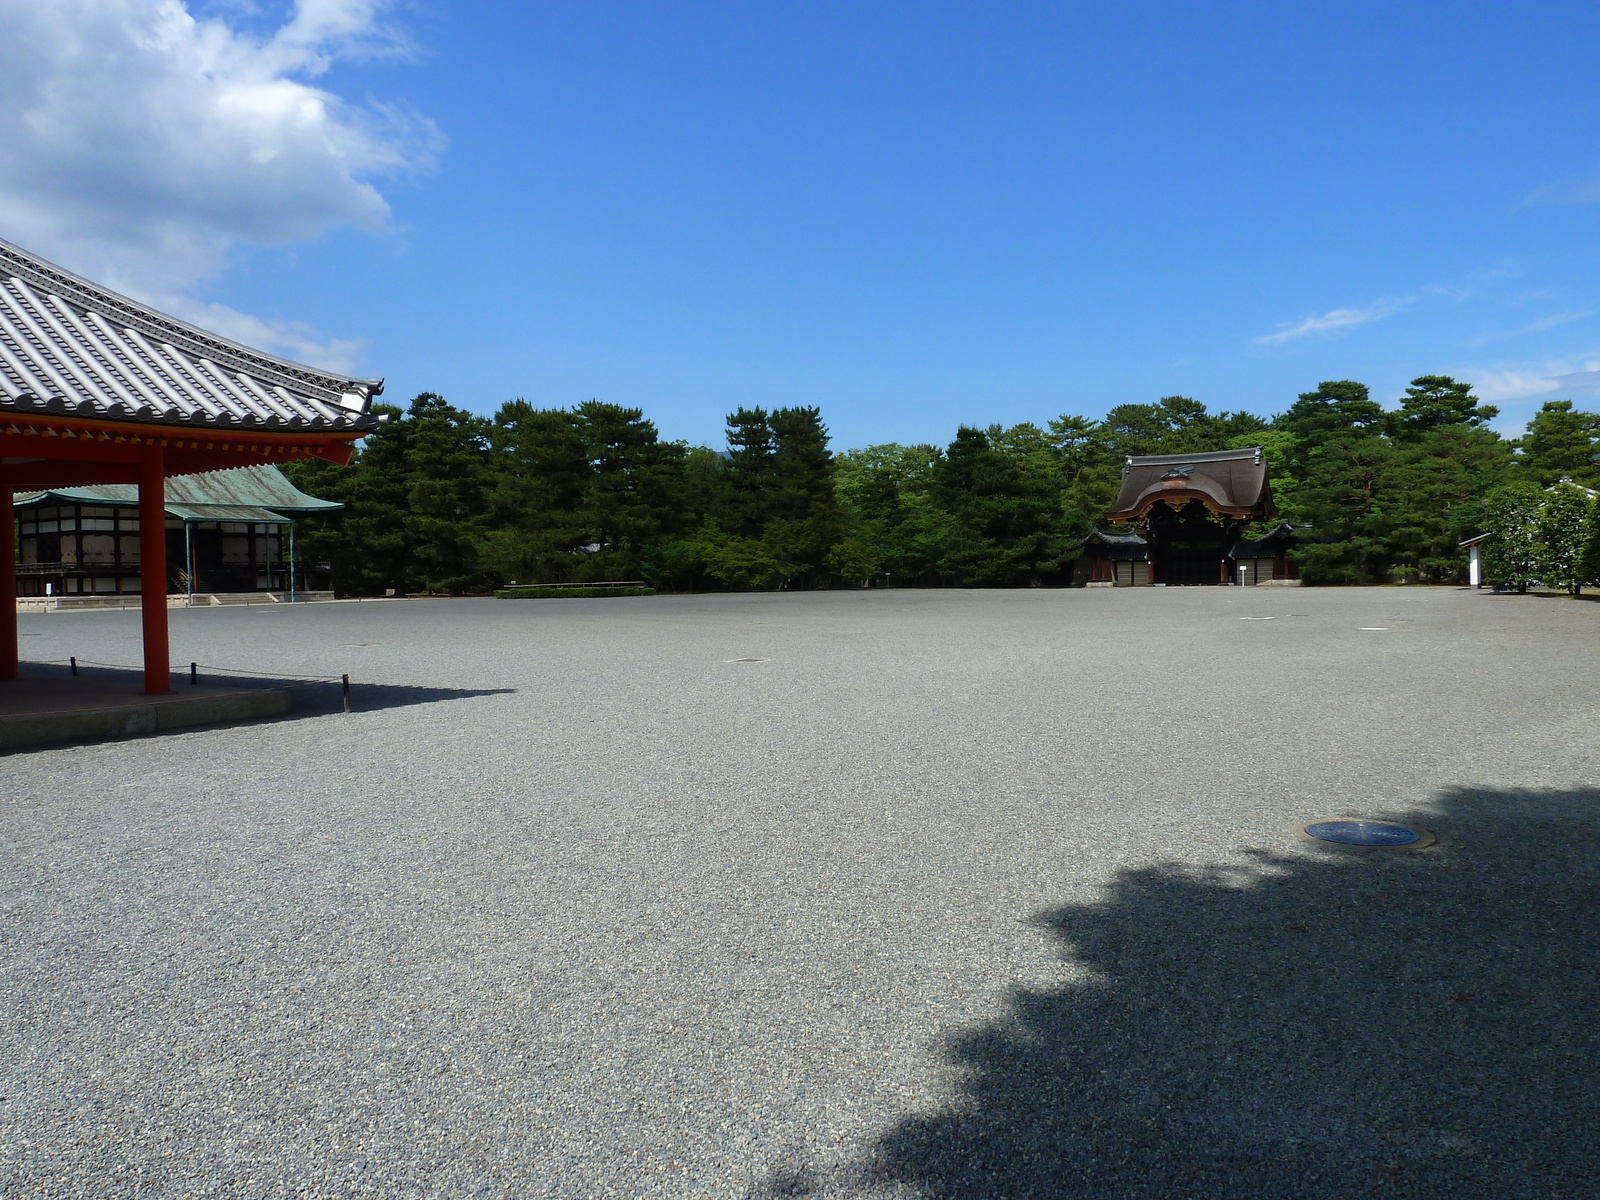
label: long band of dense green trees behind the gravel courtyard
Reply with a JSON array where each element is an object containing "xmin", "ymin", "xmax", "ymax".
[{"xmin": 290, "ymin": 376, "xmax": 1600, "ymax": 594}]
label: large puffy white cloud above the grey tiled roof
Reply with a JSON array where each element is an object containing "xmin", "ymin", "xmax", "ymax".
[{"xmin": 0, "ymin": 0, "xmax": 442, "ymax": 365}]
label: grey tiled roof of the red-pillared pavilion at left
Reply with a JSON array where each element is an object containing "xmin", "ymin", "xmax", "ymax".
[{"xmin": 0, "ymin": 240, "xmax": 382, "ymax": 434}]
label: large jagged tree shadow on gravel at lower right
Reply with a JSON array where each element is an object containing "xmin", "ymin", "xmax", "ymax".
[{"xmin": 755, "ymin": 789, "xmax": 1600, "ymax": 1200}]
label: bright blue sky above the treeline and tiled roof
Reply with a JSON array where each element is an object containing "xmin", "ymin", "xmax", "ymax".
[{"xmin": 0, "ymin": 0, "xmax": 1600, "ymax": 446}]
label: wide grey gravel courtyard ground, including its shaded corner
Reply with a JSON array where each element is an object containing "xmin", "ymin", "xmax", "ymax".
[{"xmin": 0, "ymin": 589, "xmax": 1600, "ymax": 1200}]
